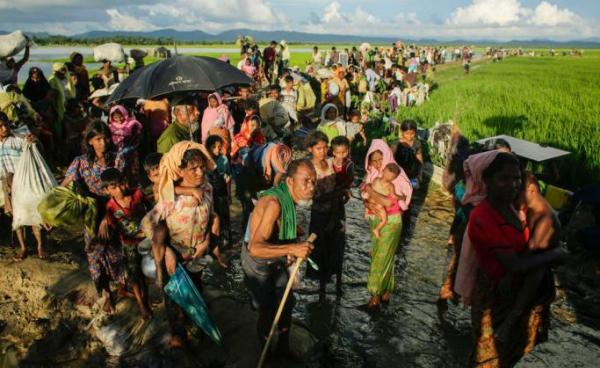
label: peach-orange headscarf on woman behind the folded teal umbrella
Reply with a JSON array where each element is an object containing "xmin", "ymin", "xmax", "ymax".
[{"xmin": 158, "ymin": 141, "xmax": 216, "ymax": 202}]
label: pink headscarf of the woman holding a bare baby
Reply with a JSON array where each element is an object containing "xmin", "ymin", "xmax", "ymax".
[{"xmin": 365, "ymin": 139, "xmax": 412, "ymax": 211}]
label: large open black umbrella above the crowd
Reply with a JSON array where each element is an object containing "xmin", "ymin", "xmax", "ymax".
[{"xmin": 107, "ymin": 56, "xmax": 254, "ymax": 104}]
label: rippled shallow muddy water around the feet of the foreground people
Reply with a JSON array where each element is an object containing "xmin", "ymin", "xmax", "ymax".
[{"xmin": 207, "ymin": 182, "xmax": 600, "ymax": 367}]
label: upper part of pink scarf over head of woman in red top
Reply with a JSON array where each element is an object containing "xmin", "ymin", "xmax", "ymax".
[{"xmin": 461, "ymin": 150, "xmax": 499, "ymax": 206}]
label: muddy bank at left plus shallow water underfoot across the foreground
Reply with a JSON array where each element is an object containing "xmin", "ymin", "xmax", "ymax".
[{"xmin": 0, "ymin": 176, "xmax": 600, "ymax": 367}]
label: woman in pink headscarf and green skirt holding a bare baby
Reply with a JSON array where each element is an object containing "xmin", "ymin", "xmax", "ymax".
[{"xmin": 361, "ymin": 139, "xmax": 412, "ymax": 308}]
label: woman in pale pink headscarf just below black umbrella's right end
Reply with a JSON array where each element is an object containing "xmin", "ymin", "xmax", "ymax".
[{"xmin": 201, "ymin": 92, "xmax": 235, "ymax": 153}]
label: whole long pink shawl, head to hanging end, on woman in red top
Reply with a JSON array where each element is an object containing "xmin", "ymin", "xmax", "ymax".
[{"xmin": 454, "ymin": 150, "xmax": 499, "ymax": 305}]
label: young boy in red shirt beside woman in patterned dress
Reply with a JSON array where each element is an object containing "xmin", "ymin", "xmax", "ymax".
[{"xmin": 99, "ymin": 168, "xmax": 150, "ymax": 319}]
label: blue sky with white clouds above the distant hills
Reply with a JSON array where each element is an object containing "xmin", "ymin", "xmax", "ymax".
[{"xmin": 0, "ymin": 0, "xmax": 600, "ymax": 41}]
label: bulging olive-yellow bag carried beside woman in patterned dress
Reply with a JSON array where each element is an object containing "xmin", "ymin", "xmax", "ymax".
[{"xmin": 38, "ymin": 186, "xmax": 97, "ymax": 234}]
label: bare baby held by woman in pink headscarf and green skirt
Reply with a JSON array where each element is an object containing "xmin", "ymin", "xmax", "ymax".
[{"xmin": 365, "ymin": 162, "xmax": 405, "ymax": 239}]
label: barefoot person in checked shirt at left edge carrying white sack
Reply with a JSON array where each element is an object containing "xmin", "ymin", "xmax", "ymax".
[{"xmin": 0, "ymin": 112, "xmax": 46, "ymax": 260}]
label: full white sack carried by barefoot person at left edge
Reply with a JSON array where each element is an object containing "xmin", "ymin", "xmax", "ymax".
[{"xmin": 12, "ymin": 141, "xmax": 58, "ymax": 230}]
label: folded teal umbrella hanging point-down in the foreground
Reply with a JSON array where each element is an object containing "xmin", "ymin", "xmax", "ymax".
[{"xmin": 164, "ymin": 264, "xmax": 223, "ymax": 345}]
